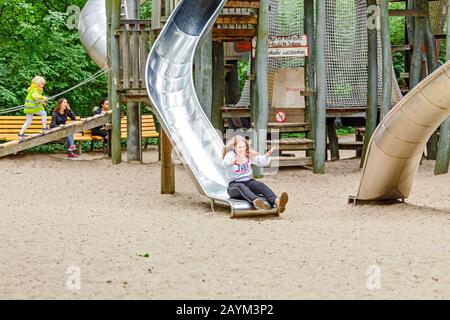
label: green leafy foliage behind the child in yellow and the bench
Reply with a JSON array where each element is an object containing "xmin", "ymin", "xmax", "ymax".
[{"xmin": 0, "ymin": 0, "xmax": 107, "ymax": 116}]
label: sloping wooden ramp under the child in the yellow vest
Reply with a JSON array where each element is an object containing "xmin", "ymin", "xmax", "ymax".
[{"xmin": 0, "ymin": 111, "xmax": 112, "ymax": 157}]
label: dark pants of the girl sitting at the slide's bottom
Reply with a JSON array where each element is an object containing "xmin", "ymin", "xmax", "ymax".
[{"xmin": 227, "ymin": 179, "xmax": 277, "ymax": 206}]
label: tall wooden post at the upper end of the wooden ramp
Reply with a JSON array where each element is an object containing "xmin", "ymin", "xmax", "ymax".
[{"xmin": 106, "ymin": 0, "xmax": 122, "ymax": 164}]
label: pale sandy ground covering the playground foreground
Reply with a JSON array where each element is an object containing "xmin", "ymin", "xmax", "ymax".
[{"xmin": 0, "ymin": 141, "xmax": 450, "ymax": 299}]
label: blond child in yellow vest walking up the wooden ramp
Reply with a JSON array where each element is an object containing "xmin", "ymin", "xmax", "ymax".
[{"xmin": 19, "ymin": 76, "xmax": 50, "ymax": 138}]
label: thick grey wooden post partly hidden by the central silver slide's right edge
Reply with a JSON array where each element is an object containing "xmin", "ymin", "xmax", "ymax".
[{"xmin": 194, "ymin": 33, "xmax": 213, "ymax": 120}]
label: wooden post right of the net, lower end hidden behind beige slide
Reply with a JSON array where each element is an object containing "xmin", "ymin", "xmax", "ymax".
[{"xmin": 380, "ymin": 0, "xmax": 392, "ymax": 119}]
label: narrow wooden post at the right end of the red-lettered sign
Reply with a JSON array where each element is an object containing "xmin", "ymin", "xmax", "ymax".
[{"xmin": 304, "ymin": 0, "xmax": 316, "ymax": 157}]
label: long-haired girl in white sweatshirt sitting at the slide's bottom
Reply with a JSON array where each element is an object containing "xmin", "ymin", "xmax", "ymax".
[{"xmin": 222, "ymin": 136, "xmax": 288, "ymax": 213}]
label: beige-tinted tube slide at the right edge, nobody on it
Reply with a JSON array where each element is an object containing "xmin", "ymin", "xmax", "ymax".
[{"xmin": 352, "ymin": 62, "xmax": 450, "ymax": 201}]
